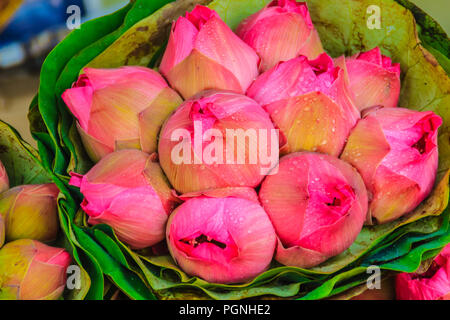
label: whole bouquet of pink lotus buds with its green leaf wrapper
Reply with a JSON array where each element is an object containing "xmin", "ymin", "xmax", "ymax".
[{"xmin": 14, "ymin": 0, "xmax": 450, "ymax": 299}]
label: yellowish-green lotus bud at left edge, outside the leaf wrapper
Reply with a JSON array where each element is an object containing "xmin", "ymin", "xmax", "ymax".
[{"xmin": 0, "ymin": 183, "xmax": 59, "ymax": 242}]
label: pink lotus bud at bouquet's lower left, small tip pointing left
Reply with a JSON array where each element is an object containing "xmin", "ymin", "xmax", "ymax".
[{"xmin": 70, "ymin": 149, "xmax": 177, "ymax": 249}]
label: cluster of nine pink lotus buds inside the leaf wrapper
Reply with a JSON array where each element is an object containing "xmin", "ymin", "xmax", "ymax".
[{"xmin": 60, "ymin": 0, "xmax": 443, "ymax": 284}]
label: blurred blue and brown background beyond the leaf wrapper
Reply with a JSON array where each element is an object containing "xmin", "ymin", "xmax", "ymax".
[{"xmin": 0, "ymin": 0, "xmax": 450, "ymax": 146}]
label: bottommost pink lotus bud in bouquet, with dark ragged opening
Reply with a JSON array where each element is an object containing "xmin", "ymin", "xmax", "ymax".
[{"xmin": 167, "ymin": 188, "xmax": 276, "ymax": 283}]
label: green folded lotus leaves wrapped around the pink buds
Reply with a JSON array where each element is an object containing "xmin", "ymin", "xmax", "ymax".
[{"xmin": 29, "ymin": 0, "xmax": 450, "ymax": 299}]
